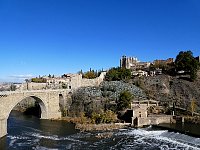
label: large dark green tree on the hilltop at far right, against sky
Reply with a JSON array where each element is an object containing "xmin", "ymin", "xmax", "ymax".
[{"xmin": 175, "ymin": 51, "xmax": 200, "ymax": 81}]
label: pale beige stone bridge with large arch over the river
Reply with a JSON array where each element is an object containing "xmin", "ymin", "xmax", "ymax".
[{"xmin": 0, "ymin": 90, "xmax": 71, "ymax": 138}]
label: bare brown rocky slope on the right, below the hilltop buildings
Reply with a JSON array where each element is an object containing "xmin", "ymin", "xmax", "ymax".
[{"xmin": 134, "ymin": 72, "xmax": 200, "ymax": 109}]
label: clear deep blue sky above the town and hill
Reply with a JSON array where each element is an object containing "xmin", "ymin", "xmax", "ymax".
[{"xmin": 0, "ymin": 0, "xmax": 200, "ymax": 81}]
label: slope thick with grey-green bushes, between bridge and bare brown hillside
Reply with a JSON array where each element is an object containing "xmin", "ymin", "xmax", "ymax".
[{"xmin": 69, "ymin": 81, "xmax": 147, "ymax": 116}]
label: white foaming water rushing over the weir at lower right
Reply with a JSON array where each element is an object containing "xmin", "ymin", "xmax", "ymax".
[{"xmin": 118, "ymin": 129, "xmax": 200, "ymax": 150}]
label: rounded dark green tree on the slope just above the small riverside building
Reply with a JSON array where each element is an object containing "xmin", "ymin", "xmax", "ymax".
[{"xmin": 117, "ymin": 91, "xmax": 133, "ymax": 111}]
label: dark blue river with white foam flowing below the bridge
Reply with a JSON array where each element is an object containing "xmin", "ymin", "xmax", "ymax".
[{"xmin": 0, "ymin": 112, "xmax": 200, "ymax": 150}]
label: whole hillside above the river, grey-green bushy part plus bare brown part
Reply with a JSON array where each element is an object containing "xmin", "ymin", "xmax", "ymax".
[{"xmin": 69, "ymin": 72, "xmax": 200, "ymax": 116}]
